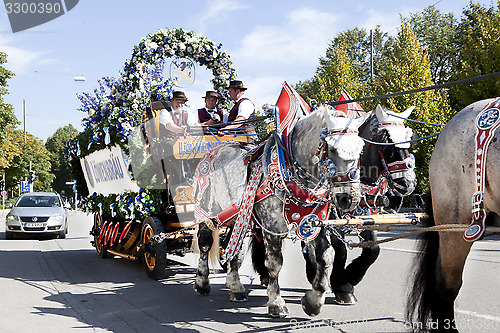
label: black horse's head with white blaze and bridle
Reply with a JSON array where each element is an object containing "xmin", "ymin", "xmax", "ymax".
[{"xmin": 362, "ymin": 105, "xmax": 416, "ymax": 196}]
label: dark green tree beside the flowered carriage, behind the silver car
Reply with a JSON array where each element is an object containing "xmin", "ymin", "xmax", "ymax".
[{"xmin": 45, "ymin": 124, "xmax": 78, "ymax": 197}]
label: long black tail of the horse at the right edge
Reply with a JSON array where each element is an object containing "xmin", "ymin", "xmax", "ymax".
[{"xmin": 406, "ymin": 192, "xmax": 439, "ymax": 328}]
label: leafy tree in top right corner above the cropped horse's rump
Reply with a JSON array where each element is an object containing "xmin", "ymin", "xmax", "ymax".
[{"xmin": 450, "ymin": 1, "xmax": 500, "ymax": 110}]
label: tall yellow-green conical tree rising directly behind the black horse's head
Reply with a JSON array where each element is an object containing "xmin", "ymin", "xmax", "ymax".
[{"xmin": 376, "ymin": 21, "xmax": 452, "ymax": 193}]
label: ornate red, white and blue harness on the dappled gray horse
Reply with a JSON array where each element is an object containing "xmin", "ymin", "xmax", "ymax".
[{"xmin": 195, "ymin": 129, "xmax": 359, "ymax": 262}]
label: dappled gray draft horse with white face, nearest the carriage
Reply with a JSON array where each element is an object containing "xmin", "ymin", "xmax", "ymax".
[{"xmin": 193, "ymin": 106, "xmax": 370, "ymax": 317}]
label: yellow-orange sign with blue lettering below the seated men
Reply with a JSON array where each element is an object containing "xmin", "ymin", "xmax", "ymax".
[{"xmin": 174, "ymin": 135, "xmax": 247, "ymax": 159}]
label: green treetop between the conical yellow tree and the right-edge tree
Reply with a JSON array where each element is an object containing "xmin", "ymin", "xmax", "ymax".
[{"xmin": 408, "ymin": 5, "xmax": 459, "ymax": 84}]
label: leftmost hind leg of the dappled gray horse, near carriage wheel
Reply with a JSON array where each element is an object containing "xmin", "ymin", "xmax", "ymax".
[{"xmin": 194, "ymin": 223, "xmax": 214, "ymax": 295}]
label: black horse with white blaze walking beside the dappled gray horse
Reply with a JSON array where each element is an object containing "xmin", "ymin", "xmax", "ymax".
[{"xmin": 294, "ymin": 105, "xmax": 416, "ymax": 305}]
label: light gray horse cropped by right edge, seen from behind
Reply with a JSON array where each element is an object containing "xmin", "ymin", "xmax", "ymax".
[{"xmin": 405, "ymin": 98, "xmax": 500, "ymax": 332}]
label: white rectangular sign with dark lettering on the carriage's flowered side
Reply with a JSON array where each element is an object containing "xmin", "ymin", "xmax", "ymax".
[{"xmin": 80, "ymin": 146, "xmax": 139, "ymax": 195}]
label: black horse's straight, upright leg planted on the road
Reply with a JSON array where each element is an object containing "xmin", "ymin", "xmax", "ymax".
[{"xmin": 330, "ymin": 235, "xmax": 357, "ymax": 305}]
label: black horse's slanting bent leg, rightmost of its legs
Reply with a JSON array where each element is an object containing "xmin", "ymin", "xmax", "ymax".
[{"xmin": 346, "ymin": 230, "xmax": 380, "ymax": 286}]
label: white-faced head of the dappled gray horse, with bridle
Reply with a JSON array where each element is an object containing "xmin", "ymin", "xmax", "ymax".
[{"xmin": 319, "ymin": 108, "xmax": 368, "ymax": 212}]
